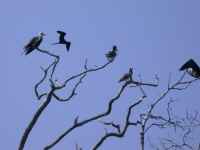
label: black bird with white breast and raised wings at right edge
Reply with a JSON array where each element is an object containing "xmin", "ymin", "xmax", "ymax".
[{"xmin": 179, "ymin": 59, "xmax": 200, "ymax": 78}]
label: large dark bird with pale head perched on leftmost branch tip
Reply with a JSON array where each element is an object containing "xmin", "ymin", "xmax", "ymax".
[{"xmin": 24, "ymin": 32, "xmax": 46, "ymax": 55}]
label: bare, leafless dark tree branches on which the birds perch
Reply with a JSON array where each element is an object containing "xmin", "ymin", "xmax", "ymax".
[{"xmin": 18, "ymin": 33, "xmax": 200, "ymax": 150}]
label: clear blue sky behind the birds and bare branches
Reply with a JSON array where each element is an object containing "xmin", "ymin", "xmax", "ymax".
[{"xmin": 0, "ymin": 0, "xmax": 200, "ymax": 150}]
